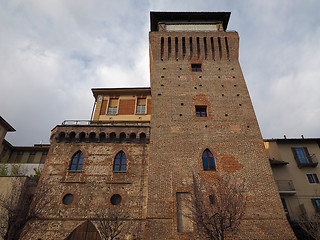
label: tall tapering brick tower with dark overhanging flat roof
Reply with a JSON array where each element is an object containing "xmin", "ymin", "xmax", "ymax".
[{"xmin": 146, "ymin": 12, "xmax": 295, "ymax": 239}]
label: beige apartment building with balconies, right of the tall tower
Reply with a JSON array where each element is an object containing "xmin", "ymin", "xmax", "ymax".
[{"xmin": 264, "ymin": 136, "xmax": 320, "ymax": 222}]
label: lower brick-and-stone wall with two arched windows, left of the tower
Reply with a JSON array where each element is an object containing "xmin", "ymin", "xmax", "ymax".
[{"xmin": 25, "ymin": 126, "xmax": 149, "ymax": 239}]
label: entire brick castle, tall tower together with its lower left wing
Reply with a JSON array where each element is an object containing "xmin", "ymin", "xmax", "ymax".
[{"xmin": 26, "ymin": 12, "xmax": 295, "ymax": 240}]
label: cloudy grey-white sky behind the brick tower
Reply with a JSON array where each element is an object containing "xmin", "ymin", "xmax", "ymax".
[{"xmin": 0, "ymin": 0, "xmax": 320, "ymax": 145}]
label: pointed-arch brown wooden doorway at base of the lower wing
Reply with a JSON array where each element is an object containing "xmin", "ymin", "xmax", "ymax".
[{"xmin": 65, "ymin": 221, "xmax": 101, "ymax": 240}]
